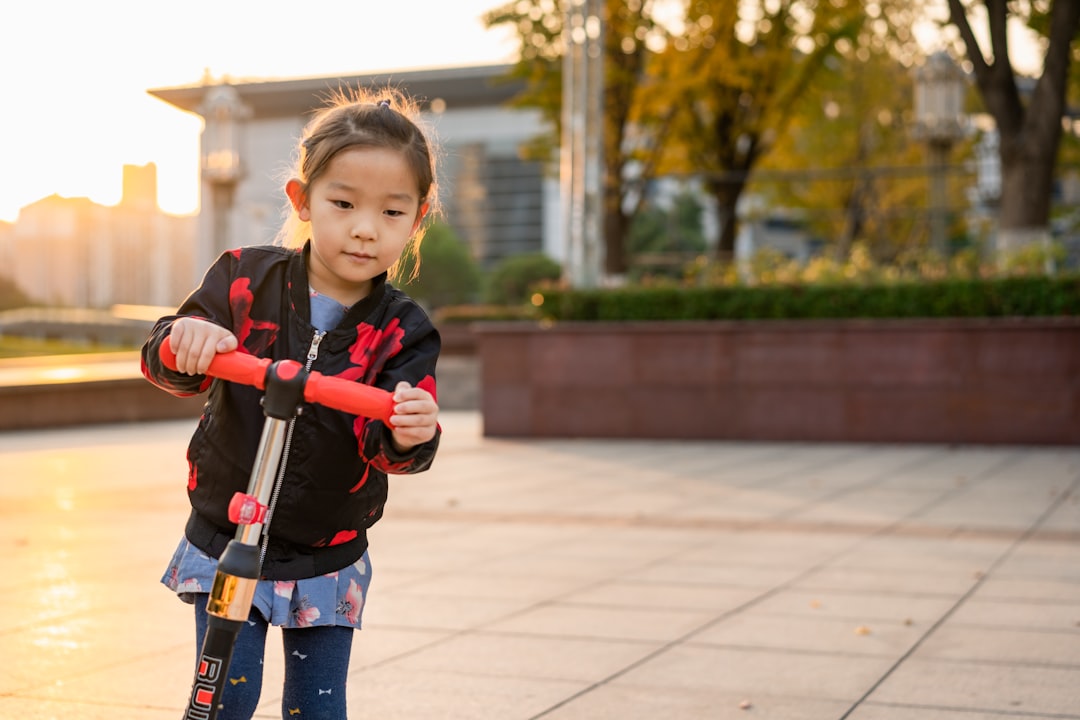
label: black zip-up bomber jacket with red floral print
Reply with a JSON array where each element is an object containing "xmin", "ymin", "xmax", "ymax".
[{"xmin": 143, "ymin": 246, "xmax": 440, "ymax": 580}]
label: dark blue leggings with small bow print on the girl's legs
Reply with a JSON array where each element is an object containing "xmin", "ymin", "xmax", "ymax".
[{"xmin": 195, "ymin": 594, "xmax": 352, "ymax": 720}]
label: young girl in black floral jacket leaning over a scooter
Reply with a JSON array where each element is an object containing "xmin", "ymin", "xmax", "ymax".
[{"xmin": 143, "ymin": 87, "xmax": 440, "ymax": 720}]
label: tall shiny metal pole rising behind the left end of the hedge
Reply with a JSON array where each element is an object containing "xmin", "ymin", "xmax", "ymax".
[{"xmin": 559, "ymin": 0, "xmax": 604, "ymax": 287}]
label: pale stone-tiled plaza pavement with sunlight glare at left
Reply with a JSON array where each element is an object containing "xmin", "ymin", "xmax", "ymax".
[{"xmin": 0, "ymin": 411, "xmax": 1080, "ymax": 720}]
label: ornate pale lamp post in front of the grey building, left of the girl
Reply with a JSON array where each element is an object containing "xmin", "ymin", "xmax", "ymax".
[{"xmin": 199, "ymin": 84, "xmax": 249, "ymax": 267}]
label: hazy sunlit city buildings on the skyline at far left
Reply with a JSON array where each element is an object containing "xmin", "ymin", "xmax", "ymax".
[{"xmin": 0, "ymin": 163, "xmax": 195, "ymax": 308}]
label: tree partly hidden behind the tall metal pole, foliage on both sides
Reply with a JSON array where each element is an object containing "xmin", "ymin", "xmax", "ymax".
[{"xmin": 484, "ymin": 0, "xmax": 662, "ymax": 275}]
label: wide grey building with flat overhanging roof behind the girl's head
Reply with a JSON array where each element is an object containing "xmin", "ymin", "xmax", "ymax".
[{"xmin": 150, "ymin": 65, "xmax": 562, "ymax": 287}]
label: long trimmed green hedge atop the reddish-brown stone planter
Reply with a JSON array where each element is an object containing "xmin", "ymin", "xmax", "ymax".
[{"xmin": 540, "ymin": 273, "xmax": 1080, "ymax": 321}]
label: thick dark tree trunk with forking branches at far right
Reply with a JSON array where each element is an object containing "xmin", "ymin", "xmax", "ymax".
[{"xmin": 948, "ymin": 0, "xmax": 1080, "ymax": 253}]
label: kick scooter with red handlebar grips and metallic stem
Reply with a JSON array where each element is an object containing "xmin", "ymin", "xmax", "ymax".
[{"xmin": 160, "ymin": 338, "xmax": 394, "ymax": 720}]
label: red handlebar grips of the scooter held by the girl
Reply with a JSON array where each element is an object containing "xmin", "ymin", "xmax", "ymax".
[{"xmin": 159, "ymin": 338, "xmax": 394, "ymax": 425}]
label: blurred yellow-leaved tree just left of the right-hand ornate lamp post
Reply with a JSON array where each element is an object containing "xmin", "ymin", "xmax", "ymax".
[{"xmin": 750, "ymin": 9, "xmax": 941, "ymax": 261}]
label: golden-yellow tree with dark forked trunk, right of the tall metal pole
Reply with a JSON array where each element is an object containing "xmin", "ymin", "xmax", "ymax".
[{"xmin": 646, "ymin": 0, "xmax": 866, "ymax": 261}]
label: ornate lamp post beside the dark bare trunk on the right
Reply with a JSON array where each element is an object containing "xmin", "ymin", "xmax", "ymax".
[{"xmin": 915, "ymin": 51, "xmax": 967, "ymax": 255}]
